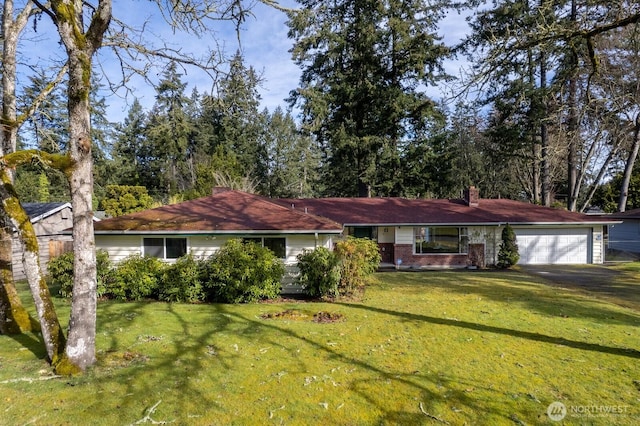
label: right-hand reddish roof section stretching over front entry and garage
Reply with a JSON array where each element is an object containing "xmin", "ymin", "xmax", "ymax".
[{"xmin": 281, "ymin": 198, "xmax": 611, "ymax": 225}]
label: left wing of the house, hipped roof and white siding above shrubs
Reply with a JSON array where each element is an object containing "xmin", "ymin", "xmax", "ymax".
[{"xmin": 94, "ymin": 188, "xmax": 342, "ymax": 292}]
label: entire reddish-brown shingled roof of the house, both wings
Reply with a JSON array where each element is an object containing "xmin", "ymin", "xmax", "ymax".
[{"xmin": 94, "ymin": 190, "xmax": 614, "ymax": 234}]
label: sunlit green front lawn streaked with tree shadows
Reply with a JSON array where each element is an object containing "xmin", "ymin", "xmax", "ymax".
[{"xmin": 0, "ymin": 267, "xmax": 640, "ymax": 425}]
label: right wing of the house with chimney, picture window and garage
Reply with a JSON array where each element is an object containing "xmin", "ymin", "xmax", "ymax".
[{"xmin": 284, "ymin": 187, "xmax": 614, "ymax": 268}]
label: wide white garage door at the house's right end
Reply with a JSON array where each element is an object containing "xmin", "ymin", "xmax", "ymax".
[{"xmin": 515, "ymin": 228, "xmax": 590, "ymax": 265}]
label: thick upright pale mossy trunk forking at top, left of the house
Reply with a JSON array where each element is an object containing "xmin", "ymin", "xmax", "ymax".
[{"xmin": 45, "ymin": 0, "xmax": 112, "ymax": 374}]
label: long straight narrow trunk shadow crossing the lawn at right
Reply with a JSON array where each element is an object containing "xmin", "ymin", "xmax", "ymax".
[{"xmin": 337, "ymin": 303, "xmax": 640, "ymax": 359}]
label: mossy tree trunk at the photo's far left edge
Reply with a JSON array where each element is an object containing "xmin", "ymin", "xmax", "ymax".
[{"xmin": 0, "ymin": 0, "xmax": 39, "ymax": 334}]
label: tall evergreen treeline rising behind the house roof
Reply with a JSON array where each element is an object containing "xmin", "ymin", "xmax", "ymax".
[{"xmin": 16, "ymin": 0, "xmax": 640, "ymax": 211}]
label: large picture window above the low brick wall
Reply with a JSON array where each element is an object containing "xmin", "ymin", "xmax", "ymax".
[{"xmin": 414, "ymin": 226, "xmax": 469, "ymax": 254}]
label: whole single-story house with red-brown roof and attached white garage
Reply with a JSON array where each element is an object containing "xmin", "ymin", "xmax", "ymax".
[{"xmin": 95, "ymin": 187, "xmax": 617, "ymax": 273}]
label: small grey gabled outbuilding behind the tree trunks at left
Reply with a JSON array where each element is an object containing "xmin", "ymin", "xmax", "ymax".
[{"xmin": 12, "ymin": 202, "xmax": 73, "ymax": 280}]
